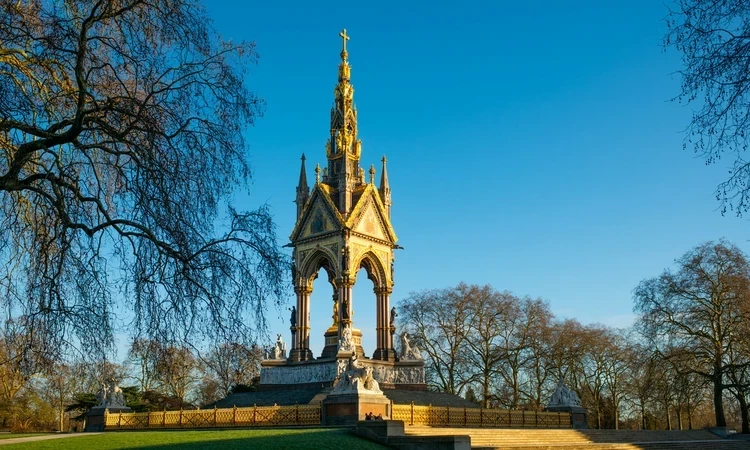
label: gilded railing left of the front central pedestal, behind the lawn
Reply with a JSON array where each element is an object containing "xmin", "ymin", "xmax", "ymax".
[{"xmin": 104, "ymin": 404, "xmax": 320, "ymax": 430}]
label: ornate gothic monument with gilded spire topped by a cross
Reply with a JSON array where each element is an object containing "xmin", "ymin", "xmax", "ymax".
[{"xmin": 261, "ymin": 30, "xmax": 426, "ymax": 404}]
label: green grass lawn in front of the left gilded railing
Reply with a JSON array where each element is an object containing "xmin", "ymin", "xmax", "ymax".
[{"xmin": 1, "ymin": 428, "xmax": 385, "ymax": 450}]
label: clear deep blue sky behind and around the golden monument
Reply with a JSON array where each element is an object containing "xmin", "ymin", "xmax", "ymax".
[{"xmin": 207, "ymin": 0, "xmax": 750, "ymax": 355}]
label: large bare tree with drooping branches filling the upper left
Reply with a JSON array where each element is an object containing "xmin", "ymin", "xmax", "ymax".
[{"xmin": 0, "ymin": 0, "xmax": 288, "ymax": 360}]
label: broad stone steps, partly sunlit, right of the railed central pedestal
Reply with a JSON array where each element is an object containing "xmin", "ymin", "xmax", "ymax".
[{"xmin": 405, "ymin": 426, "xmax": 750, "ymax": 450}]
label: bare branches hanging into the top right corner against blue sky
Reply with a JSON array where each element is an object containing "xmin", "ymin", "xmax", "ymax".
[{"xmin": 664, "ymin": 0, "xmax": 750, "ymax": 215}]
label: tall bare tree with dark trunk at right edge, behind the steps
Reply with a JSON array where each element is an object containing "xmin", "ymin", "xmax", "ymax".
[{"xmin": 635, "ymin": 241, "xmax": 750, "ymax": 426}]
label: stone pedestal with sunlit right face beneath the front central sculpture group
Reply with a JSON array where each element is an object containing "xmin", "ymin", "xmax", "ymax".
[{"xmin": 322, "ymin": 393, "xmax": 391, "ymax": 426}]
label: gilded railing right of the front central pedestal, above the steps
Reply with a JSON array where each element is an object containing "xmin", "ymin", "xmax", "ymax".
[{"xmin": 391, "ymin": 403, "xmax": 570, "ymax": 428}]
